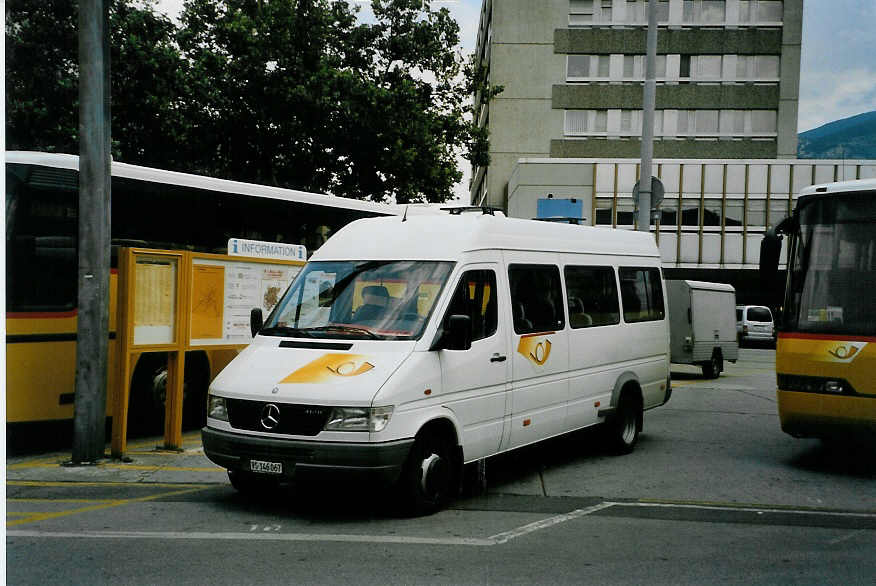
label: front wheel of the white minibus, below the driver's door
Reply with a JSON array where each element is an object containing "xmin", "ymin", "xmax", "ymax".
[{"xmin": 401, "ymin": 431, "xmax": 454, "ymax": 515}]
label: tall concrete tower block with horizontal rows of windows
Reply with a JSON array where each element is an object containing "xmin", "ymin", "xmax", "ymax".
[{"xmin": 471, "ymin": 0, "xmax": 803, "ymax": 208}]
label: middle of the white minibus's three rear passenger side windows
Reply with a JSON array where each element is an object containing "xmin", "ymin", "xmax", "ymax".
[{"xmin": 563, "ymin": 266, "xmax": 620, "ymax": 328}]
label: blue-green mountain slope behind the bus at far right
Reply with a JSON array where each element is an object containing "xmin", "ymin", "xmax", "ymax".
[{"xmin": 797, "ymin": 110, "xmax": 876, "ymax": 159}]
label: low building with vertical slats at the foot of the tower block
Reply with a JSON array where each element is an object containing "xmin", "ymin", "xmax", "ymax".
[{"xmin": 507, "ymin": 158, "xmax": 876, "ymax": 304}]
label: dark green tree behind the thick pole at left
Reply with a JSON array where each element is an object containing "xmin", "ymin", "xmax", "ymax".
[{"xmin": 6, "ymin": 0, "xmax": 186, "ymax": 168}]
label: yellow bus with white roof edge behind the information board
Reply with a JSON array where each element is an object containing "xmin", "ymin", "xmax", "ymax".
[{"xmin": 6, "ymin": 151, "xmax": 395, "ymax": 441}]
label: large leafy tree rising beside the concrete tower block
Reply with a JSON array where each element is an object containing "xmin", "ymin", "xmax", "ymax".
[{"xmin": 179, "ymin": 0, "xmax": 476, "ymax": 203}]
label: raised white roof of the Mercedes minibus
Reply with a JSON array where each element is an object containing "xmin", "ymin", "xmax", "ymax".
[{"xmin": 310, "ymin": 212, "xmax": 660, "ymax": 260}]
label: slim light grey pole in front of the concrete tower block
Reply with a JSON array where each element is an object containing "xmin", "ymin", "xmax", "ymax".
[{"xmin": 637, "ymin": 0, "xmax": 657, "ymax": 232}]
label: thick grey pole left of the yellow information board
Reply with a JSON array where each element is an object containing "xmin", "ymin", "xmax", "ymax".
[{"xmin": 72, "ymin": 0, "xmax": 110, "ymax": 464}]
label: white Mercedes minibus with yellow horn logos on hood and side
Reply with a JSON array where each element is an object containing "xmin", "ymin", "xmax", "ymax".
[{"xmin": 202, "ymin": 208, "xmax": 671, "ymax": 513}]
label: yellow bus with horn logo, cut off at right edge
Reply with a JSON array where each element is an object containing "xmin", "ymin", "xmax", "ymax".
[{"xmin": 761, "ymin": 179, "xmax": 876, "ymax": 438}]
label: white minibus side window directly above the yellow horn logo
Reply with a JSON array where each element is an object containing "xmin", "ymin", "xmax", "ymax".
[{"xmin": 508, "ymin": 265, "xmax": 566, "ymax": 334}]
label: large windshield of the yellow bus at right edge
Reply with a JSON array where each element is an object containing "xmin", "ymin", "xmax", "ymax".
[{"xmin": 784, "ymin": 192, "xmax": 876, "ymax": 335}]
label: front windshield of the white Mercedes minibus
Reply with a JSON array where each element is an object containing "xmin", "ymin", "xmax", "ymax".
[{"xmin": 260, "ymin": 260, "xmax": 453, "ymax": 340}]
